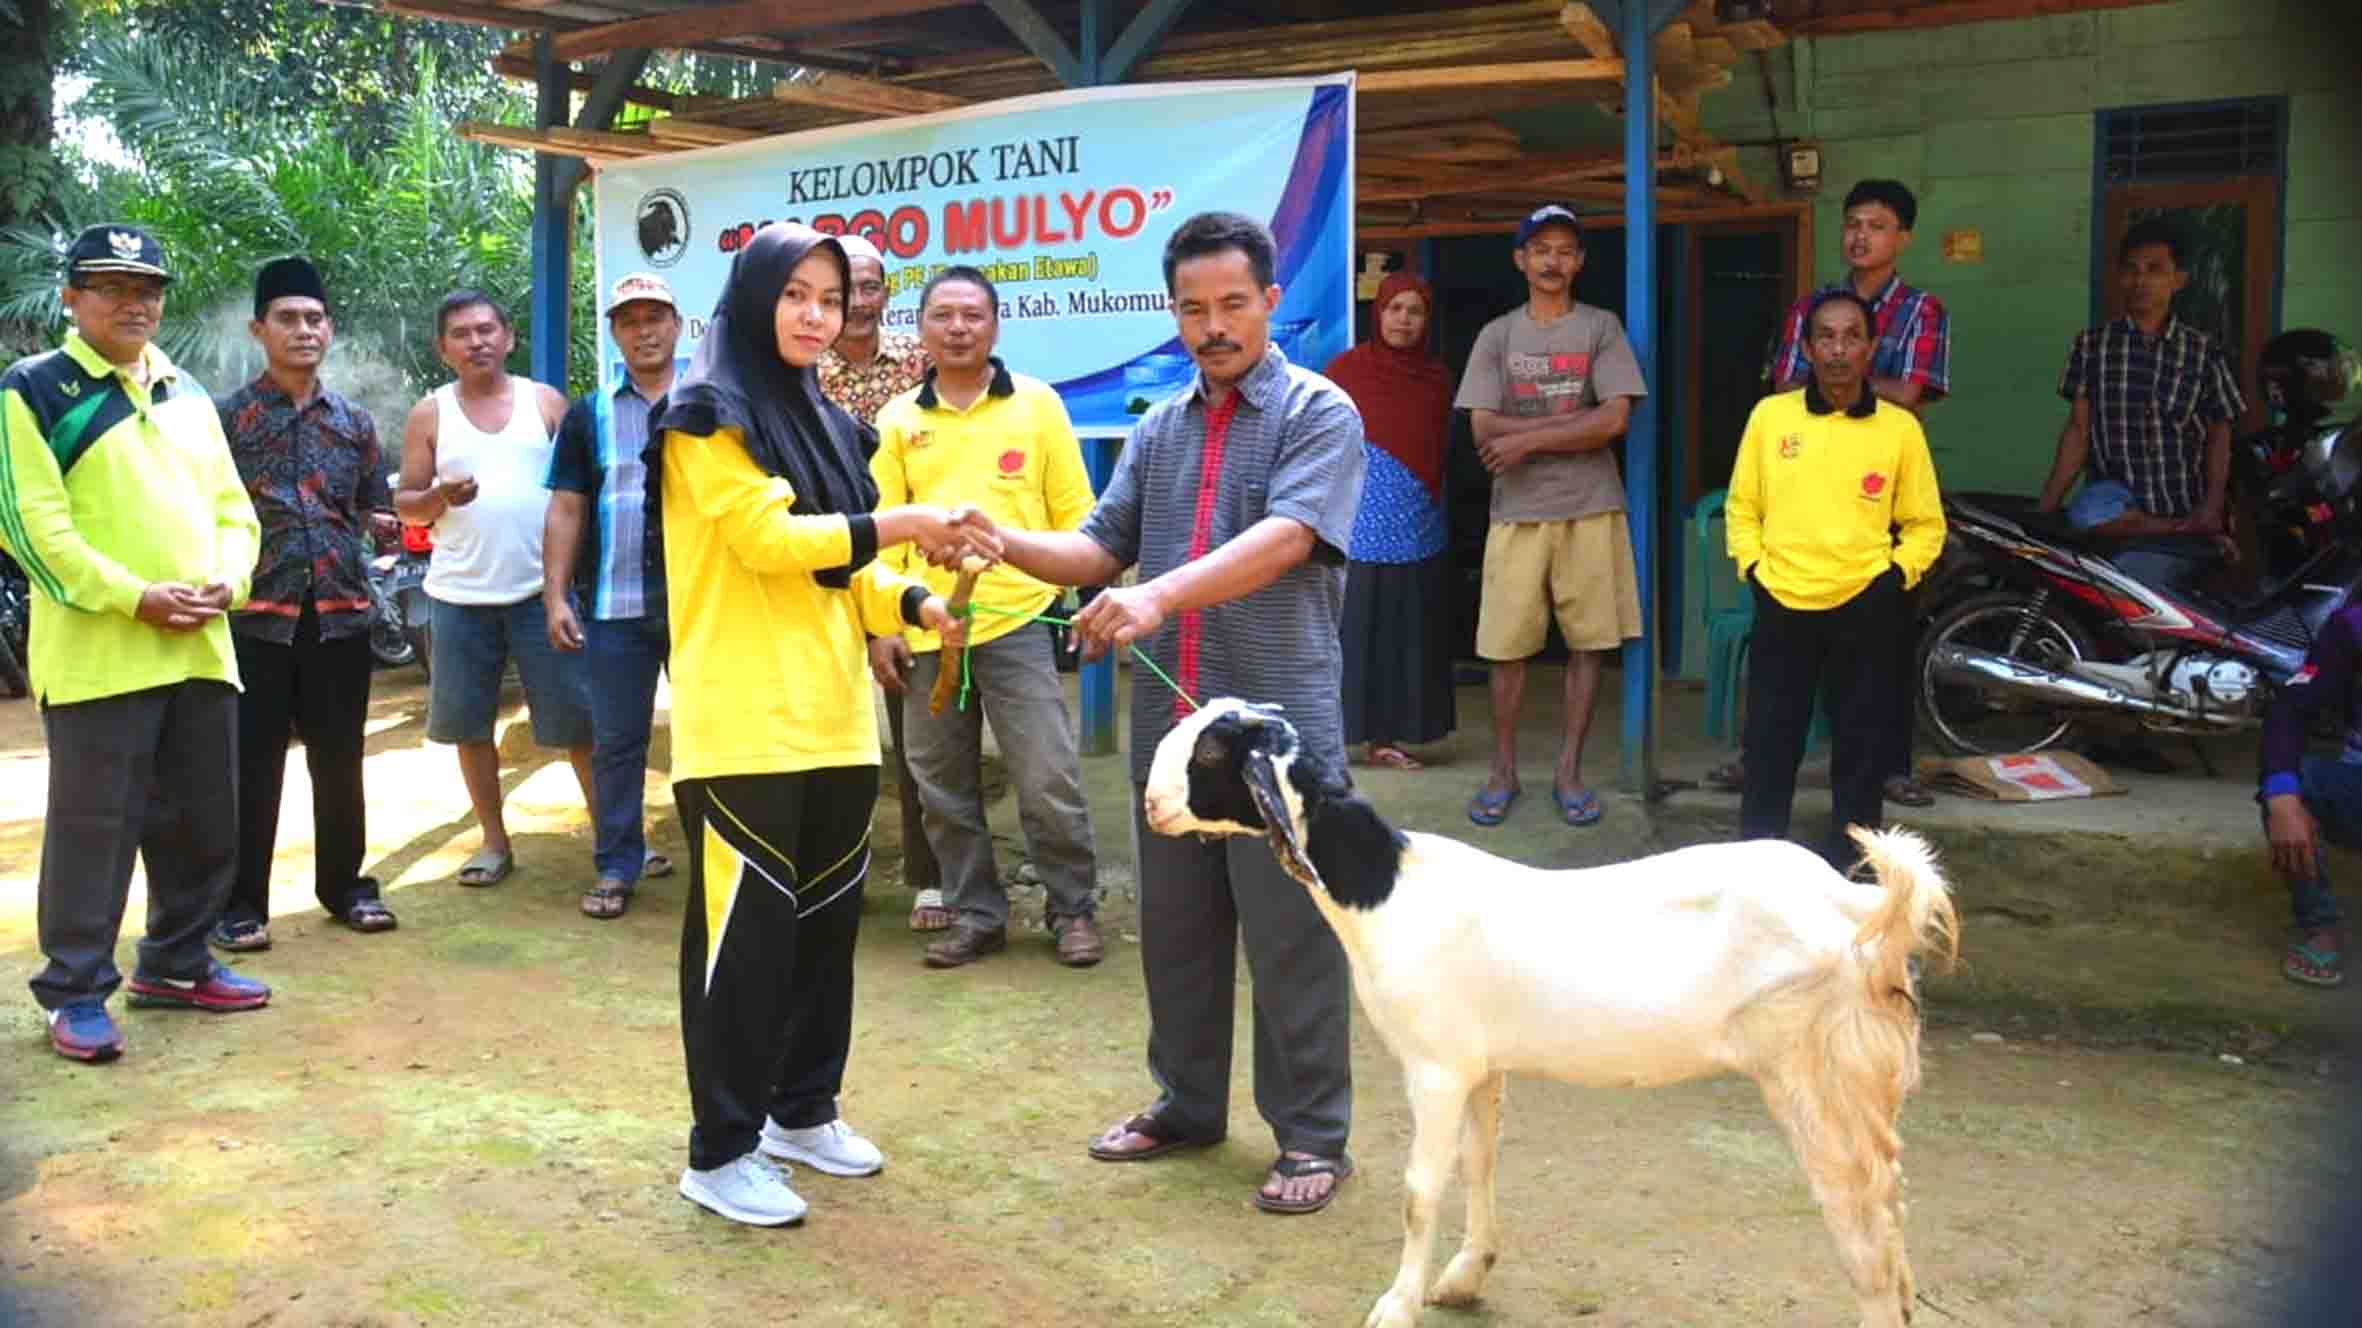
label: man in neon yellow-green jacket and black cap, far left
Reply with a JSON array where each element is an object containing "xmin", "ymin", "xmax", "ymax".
[{"xmin": 0, "ymin": 224, "xmax": 272, "ymax": 1061}]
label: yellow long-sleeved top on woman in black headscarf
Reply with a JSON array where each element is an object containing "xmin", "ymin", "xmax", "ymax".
[{"xmin": 661, "ymin": 428, "xmax": 924, "ymax": 780}]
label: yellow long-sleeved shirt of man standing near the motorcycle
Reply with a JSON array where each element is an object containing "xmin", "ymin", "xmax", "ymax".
[{"xmin": 1724, "ymin": 390, "xmax": 1944, "ymax": 610}]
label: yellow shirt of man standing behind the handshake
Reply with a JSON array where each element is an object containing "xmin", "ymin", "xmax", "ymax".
[{"xmin": 869, "ymin": 366, "xmax": 1091, "ymax": 655}]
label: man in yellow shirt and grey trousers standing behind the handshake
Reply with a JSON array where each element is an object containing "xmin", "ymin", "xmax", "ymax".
[{"xmin": 869, "ymin": 267, "xmax": 1105, "ymax": 969}]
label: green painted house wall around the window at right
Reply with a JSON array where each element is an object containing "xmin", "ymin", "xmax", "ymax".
[{"xmin": 1705, "ymin": 0, "xmax": 2362, "ymax": 492}]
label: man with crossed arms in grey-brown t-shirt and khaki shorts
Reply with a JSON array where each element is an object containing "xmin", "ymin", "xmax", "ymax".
[{"xmin": 1453, "ymin": 203, "xmax": 1649, "ymax": 825}]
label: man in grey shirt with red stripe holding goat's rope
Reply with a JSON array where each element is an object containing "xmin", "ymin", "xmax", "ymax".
[{"xmin": 964, "ymin": 213, "xmax": 1363, "ymax": 1212}]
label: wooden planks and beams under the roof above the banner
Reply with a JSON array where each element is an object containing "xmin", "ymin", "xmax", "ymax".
[{"xmin": 401, "ymin": 0, "xmax": 2154, "ymax": 239}]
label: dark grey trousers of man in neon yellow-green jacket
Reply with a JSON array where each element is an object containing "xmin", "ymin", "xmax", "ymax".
[{"xmin": 33, "ymin": 681, "xmax": 239, "ymax": 1009}]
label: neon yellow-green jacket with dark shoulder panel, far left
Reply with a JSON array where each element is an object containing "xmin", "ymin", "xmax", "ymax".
[{"xmin": 0, "ymin": 333, "xmax": 262, "ymax": 707}]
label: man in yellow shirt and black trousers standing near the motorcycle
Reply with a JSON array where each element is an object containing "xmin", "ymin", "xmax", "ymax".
[{"xmin": 1724, "ymin": 288, "xmax": 1944, "ymax": 867}]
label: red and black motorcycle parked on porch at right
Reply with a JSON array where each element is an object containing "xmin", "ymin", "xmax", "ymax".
[{"xmin": 1916, "ymin": 330, "xmax": 2362, "ymax": 756}]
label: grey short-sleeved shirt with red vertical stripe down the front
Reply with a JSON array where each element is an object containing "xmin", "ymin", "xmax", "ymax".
[{"xmin": 1082, "ymin": 345, "xmax": 1365, "ymax": 782}]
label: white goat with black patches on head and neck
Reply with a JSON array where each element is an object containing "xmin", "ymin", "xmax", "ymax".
[{"xmin": 1146, "ymin": 699, "xmax": 1958, "ymax": 1328}]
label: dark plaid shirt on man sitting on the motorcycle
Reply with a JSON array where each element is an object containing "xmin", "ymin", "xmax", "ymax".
[{"xmin": 2060, "ymin": 319, "xmax": 2246, "ymax": 517}]
